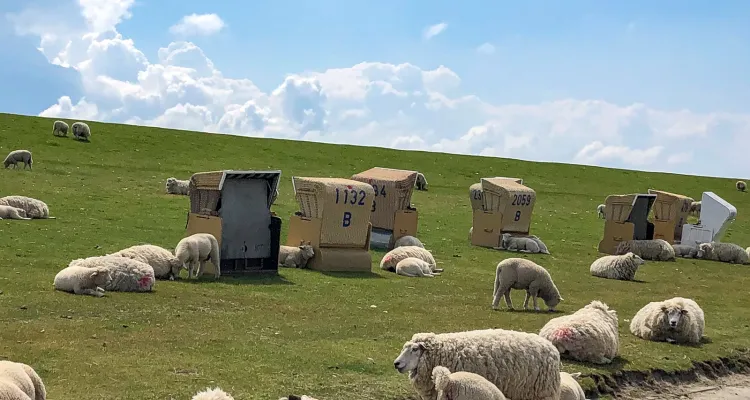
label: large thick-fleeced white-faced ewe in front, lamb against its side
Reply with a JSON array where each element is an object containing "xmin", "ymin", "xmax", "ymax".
[{"xmin": 393, "ymin": 329, "xmax": 561, "ymax": 400}]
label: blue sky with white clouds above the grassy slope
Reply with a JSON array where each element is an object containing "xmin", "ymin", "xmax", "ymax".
[{"xmin": 0, "ymin": 0, "xmax": 750, "ymax": 178}]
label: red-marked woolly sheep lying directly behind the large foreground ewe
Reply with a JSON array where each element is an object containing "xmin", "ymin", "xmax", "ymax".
[{"xmin": 539, "ymin": 300, "xmax": 620, "ymax": 364}]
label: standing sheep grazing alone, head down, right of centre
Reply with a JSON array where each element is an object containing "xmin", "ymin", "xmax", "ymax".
[{"xmin": 492, "ymin": 258, "xmax": 563, "ymax": 311}]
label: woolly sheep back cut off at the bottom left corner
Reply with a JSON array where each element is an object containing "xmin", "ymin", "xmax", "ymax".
[{"xmin": 0, "ymin": 360, "xmax": 47, "ymax": 400}]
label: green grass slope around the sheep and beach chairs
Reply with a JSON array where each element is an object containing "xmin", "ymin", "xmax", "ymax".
[{"xmin": 0, "ymin": 114, "xmax": 750, "ymax": 400}]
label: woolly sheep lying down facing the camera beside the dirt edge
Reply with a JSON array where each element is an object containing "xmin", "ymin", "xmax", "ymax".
[{"xmin": 630, "ymin": 297, "xmax": 706, "ymax": 344}]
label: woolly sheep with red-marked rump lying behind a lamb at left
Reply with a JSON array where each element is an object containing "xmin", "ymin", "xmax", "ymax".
[{"xmin": 68, "ymin": 256, "xmax": 156, "ymax": 292}]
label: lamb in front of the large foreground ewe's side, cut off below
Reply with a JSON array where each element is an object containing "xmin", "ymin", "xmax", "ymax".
[{"xmin": 432, "ymin": 366, "xmax": 506, "ymax": 400}]
